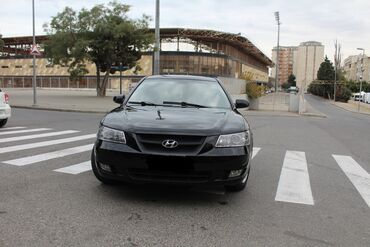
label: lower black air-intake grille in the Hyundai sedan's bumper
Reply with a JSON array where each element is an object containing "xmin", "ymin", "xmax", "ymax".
[{"xmin": 128, "ymin": 168, "xmax": 210, "ymax": 183}]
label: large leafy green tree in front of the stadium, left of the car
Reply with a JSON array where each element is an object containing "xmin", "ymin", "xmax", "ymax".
[{"xmin": 44, "ymin": 1, "xmax": 153, "ymax": 96}]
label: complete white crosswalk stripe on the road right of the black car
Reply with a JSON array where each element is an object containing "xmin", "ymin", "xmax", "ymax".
[{"xmin": 275, "ymin": 151, "xmax": 314, "ymax": 205}]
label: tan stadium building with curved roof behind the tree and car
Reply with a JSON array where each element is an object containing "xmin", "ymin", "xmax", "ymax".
[{"xmin": 0, "ymin": 28, "xmax": 273, "ymax": 90}]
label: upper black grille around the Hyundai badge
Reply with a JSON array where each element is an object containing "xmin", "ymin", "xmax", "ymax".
[{"xmin": 136, "ymin": 134, "xmax": 206, "ymax": 154}]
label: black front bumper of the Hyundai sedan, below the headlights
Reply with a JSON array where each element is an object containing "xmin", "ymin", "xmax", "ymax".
[{"xmin": 93, "ymin": 141, "xmax": 252, "ymax": 185}]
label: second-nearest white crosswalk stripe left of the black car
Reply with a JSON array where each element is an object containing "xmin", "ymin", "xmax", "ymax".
[{"xmin": 2, "ymin": 144, "xmax": 94, "ymax": 166}]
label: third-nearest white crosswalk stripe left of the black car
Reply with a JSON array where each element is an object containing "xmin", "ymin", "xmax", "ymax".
[{"xmin": 0, "ymin": 134, "xmax": 96, "ymax": 154}]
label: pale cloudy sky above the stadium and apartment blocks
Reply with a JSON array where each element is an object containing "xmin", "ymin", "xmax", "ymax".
[{"xmin": 0, "ymin": 0, "xmax": 370, "ymax": 61}]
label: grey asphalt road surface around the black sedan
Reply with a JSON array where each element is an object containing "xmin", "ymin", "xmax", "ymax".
[{"xmin": 0, "ymin": 97, "xmax": 370, "ymax": 247}]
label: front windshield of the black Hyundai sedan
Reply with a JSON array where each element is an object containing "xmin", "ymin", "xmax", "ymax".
[{"xmin": 128, "ymin": 78, "xmax": 231, "ymax": 108}]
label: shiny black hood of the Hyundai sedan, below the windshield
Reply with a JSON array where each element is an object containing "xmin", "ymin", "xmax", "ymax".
[{"xmin": 102, "ymin": 106, "xmax": 249, "ymax": 136}]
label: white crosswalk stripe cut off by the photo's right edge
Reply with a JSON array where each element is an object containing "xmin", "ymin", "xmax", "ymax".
[{"xmin": 333, "ymin": 154, "xmax": 370, "ymax": 207}]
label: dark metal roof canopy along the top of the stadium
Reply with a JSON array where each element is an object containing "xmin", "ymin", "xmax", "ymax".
[{"xmin": 2, "ymin": 28, "xmax": 273, "ymax": 66}]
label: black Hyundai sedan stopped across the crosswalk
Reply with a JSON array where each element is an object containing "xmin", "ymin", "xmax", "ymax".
[{"xmin": 91, "ymin": 75, "xmax": 253, "ymax": 191}]
